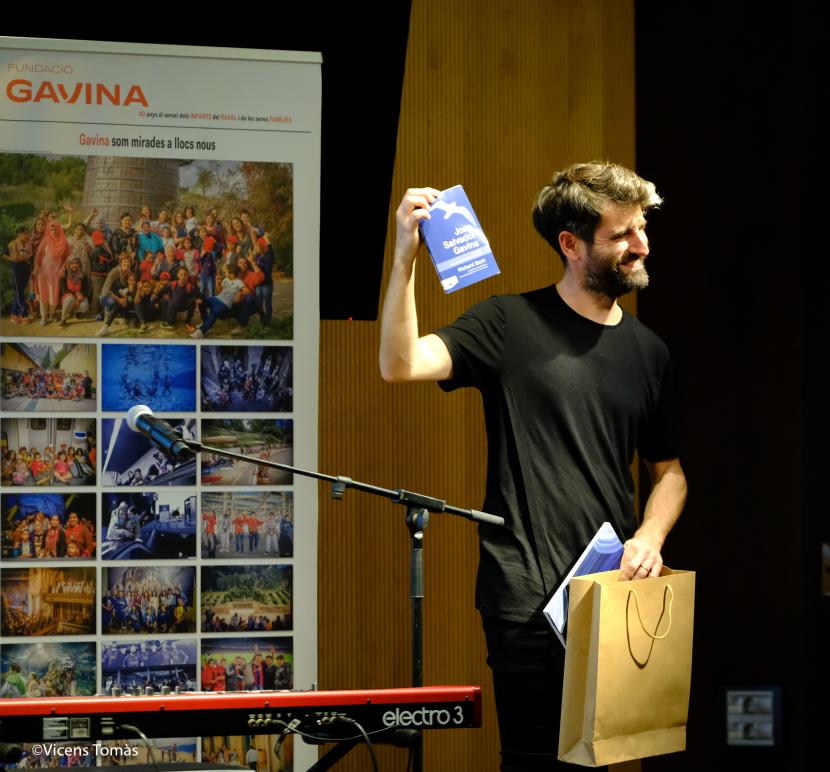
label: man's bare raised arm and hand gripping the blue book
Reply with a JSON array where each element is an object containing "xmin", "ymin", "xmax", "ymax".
[{"xmin": 380, "ymin": 188, "xmax": 452, "ymax": 383}]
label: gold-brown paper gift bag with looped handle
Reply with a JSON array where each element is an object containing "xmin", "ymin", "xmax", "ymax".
[{"xmin": 559, "ymin": 567, "xmax": 695, "ymax": 767}]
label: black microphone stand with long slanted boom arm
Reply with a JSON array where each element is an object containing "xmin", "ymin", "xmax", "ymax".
[{"xmin": 182, "ymin": 439, "xmax": 504, "ymax": 772}]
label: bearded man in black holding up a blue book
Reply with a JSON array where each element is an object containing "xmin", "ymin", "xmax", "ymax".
[{"xmin": 380, "ymin": 163, "xmax": 686, "ymax": 772}]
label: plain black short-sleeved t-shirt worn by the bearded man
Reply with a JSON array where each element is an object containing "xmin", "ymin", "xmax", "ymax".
[{"xmin": 436, "ymin": 286, "xmax": 678, "ymax": 621}]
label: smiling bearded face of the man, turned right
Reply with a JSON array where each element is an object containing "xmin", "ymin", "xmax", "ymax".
[{"xmin": 583, "ymin": 204, "xmax": 649, "ymax": 298}]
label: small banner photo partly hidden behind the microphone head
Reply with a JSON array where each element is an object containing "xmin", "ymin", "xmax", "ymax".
[{"xmin": 101, "ymin": 418, "xmax": 196, "ymax": 487}]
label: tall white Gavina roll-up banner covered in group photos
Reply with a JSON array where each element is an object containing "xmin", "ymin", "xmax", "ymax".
[{"xmin": 0, "ymin": 34, "xmax": 319, "ymax": 772}]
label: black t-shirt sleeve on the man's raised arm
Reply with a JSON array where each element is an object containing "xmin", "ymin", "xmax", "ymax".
[{"xmin": 435, "ymin": 297, "xmax": 504, "ymax": 391}]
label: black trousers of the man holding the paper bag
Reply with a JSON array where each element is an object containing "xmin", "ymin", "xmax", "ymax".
[{"xmin": 482, "ymin": 614, "xmax": 605, "ymax": 772}]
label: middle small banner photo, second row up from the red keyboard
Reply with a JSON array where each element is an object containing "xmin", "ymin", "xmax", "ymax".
[{"xmin": 101, "ymin": 566, "xmax": 196, "ymax": 635}]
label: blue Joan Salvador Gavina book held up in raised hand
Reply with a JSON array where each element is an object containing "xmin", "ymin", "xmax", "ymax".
[{"xmin": 421, "ymin": 185, "xmax": 501, "ymax": 293}]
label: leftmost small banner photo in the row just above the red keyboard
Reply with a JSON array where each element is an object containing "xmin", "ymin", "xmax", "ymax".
[{"xmin": 0, "ymin": 642, "xmax": 96, "ymax": 697}]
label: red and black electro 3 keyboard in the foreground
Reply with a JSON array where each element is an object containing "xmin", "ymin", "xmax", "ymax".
[{"xmin": 0, "ymin": 686, "xmax": 481, "ymax": 743}]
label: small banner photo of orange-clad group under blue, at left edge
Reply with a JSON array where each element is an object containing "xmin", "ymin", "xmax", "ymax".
[{"xmin": 0, "ymin": 493, "xmax": 97, "ymax": 560}]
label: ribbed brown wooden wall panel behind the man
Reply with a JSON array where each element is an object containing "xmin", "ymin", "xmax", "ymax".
[{"xmin": 318, "ymin": 0, "xmax": 634, "ymax": 772}]
